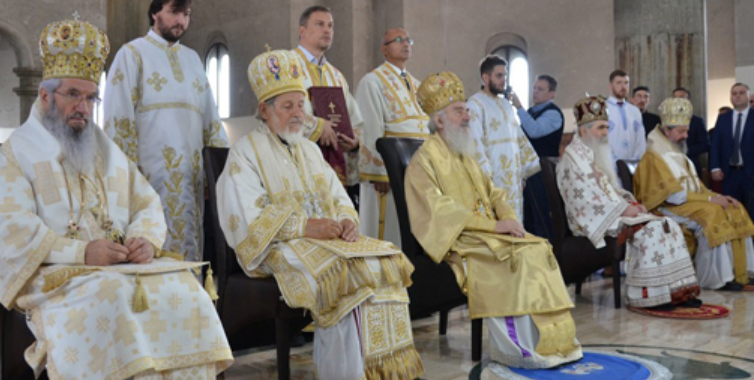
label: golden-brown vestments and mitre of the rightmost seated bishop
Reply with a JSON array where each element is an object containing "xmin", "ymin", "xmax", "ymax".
[{"xmin": 634, "ymin": 99, "xmax": 754, "ymax": 289}]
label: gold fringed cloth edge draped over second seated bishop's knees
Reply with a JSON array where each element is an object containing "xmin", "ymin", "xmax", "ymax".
[{"xmin": 317, "ymin": 254, "xmax": 414, "ymax": 315}]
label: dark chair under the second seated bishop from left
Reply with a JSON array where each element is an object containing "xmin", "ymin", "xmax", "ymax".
[{"xmin": 203, "ymin": 147, "xmax": 310, "ymax": 380}]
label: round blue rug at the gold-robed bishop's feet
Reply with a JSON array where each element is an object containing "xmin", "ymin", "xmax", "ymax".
[{"xmin": 488, "ymin": 352, "xmax": 673, "ymax": 380}]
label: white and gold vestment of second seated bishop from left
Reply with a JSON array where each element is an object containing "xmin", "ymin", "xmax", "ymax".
[{"xmin": 217, "ymin": 121, "xmax": 421, "ymax": 379}]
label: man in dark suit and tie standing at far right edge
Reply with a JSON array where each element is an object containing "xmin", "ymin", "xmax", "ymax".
[{"xmin": 710, "ymin": 83, "xmax": 754, "ymax": 215}]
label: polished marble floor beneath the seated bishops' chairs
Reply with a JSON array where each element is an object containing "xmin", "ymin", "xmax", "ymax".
[{"xmin": 225, "ymin": 277, "xmax": 754, "ymax": 380}]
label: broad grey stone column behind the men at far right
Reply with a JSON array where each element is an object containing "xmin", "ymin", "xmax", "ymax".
[{"xmin": 605, "ymin": 0, "xmax": 707, "ymax": 116}]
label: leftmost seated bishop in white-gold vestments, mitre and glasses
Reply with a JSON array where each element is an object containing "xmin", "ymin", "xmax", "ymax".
[{"xmin": 0, "ymin": 20, "xmax": 233, "ymax": 380}]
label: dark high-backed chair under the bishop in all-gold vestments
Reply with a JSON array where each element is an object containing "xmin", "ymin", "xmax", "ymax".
[{"xmin": 377, "ymin": 138, "xmax": 482, "ymax": 361}]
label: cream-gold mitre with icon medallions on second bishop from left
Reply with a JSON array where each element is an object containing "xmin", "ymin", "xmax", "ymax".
[{"xmin": 247, "ymin": 48, "xmax": 306, "ymax": 103}]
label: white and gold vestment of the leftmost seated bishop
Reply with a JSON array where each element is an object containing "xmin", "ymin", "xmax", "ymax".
[{"xmin": 0, "ymin": 106, "xmax": 233, "ymax": 380}]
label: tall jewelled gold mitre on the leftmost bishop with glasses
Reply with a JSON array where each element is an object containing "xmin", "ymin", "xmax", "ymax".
[{"xmin": 39, "ymin": 20, "xmax": 110, "ymax": 83}]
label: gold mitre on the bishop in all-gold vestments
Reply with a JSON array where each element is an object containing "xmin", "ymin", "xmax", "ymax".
[{"xmin": 416, "ymin": 71, "xmax": 466, "ymax": 115}]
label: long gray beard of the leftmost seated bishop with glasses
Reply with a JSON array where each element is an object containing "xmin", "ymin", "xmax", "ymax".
[{"xmin": 42, "ymin": 101, "xmax": 98, "ymax": 174}]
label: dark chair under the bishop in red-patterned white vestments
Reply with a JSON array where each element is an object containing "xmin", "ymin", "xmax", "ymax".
[{"xmin": 540, "ymin": 158, "xmax": 625, "ymax": 309}]
